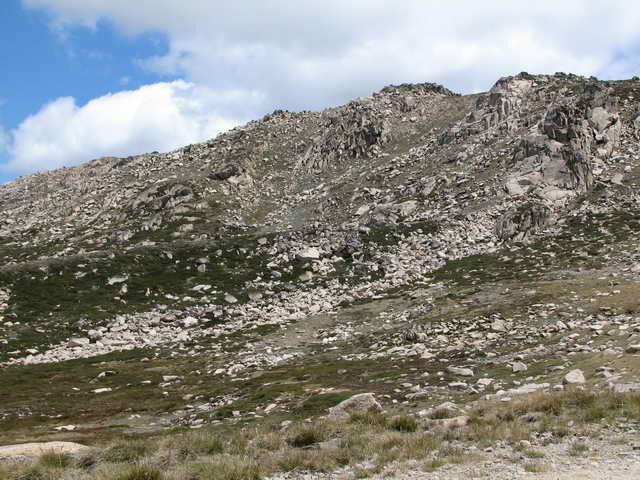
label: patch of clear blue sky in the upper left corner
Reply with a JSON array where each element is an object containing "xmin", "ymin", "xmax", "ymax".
[{"xmin": 0, "ymin": 0, "xmax": 171, "ymax": 182}]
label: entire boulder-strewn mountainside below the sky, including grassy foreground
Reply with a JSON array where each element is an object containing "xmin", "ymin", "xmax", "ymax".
[{"xmin": 0, "ymin": 73, "xmax": 640, "ymax": 480}]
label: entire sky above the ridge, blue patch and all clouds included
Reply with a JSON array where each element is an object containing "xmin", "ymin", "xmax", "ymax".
[{"xmin": 0, "ymin": 0, "xmax": 640, "ymax": 182}]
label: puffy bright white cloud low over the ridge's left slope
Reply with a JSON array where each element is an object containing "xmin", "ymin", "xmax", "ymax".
[{"xmin": 1, "ymin": 81, "xmax": 260, "ymax": 174}]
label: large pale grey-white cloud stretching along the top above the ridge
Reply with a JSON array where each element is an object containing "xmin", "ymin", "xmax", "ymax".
[{"xmin": 24, "ymin": 0, "xmax": 640, "ymax": 104}]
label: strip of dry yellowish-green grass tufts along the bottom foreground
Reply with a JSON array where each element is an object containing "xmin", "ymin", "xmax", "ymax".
[{"xmin": 0, "ymin": 389, "xmax": 640, "ymax": 480}]
